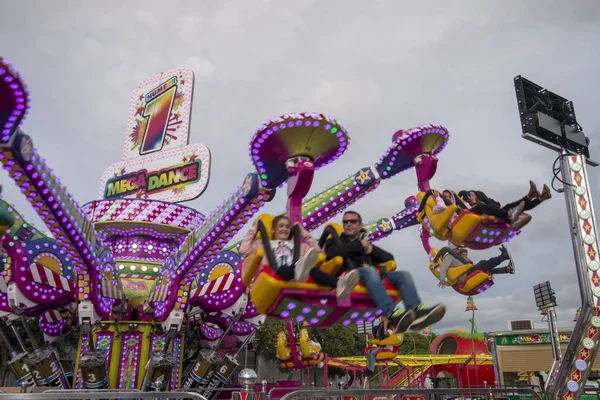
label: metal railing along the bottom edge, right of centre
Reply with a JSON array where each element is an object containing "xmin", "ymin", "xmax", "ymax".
[{"xmin": 280, "ymin": 388, "xmax": 543, "ymax": 400}]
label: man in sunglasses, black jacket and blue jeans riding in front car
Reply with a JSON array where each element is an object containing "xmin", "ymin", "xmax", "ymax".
[{"xmin": 324, "ymin": 211, "xmax": 446, "ymax": 333}]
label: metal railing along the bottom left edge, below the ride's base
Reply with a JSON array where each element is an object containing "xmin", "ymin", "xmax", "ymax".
[{"xmin": 0, "ymin": 389, "xmax": 207, "ymax": 400}]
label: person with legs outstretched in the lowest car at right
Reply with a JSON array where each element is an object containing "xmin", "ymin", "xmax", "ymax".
[{"xmin": 434, "ymin": 242, "xmax": 515, "ymax": 288}]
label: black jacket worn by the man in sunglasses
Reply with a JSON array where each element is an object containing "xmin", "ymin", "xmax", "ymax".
[{"xmin": 324, "ymin": 233, "xmax": 394, "ymax": 275}]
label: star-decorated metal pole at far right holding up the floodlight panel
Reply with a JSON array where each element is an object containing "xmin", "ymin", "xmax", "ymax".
[{"xmin": 546, "ymin": 150, "xmax": 600, "ymax": 400}]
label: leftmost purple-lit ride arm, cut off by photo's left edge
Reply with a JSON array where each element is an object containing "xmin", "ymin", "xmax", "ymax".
[{"xmin": 0, "ymin": 59, "xmax": 119, "ymax": 316}]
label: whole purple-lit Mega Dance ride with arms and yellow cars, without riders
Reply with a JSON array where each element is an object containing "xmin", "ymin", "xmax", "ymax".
[{"xmin": 0, "ymin": 54, "xmax": 583, "ymax": 398}]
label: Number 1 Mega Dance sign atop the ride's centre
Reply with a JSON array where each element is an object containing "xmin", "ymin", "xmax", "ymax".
[{"xmin": 99, "ymin": 68, "xmax": 210, "ymax": 203}]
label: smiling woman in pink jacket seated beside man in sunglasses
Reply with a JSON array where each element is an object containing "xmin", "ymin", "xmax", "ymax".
[{"xmin": 240, "ymin": 215, "xmax": 321, "ymax": 282}]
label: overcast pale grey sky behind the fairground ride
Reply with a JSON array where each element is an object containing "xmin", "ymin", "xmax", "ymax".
[{"xmin": 0, "ymin": 0, "xmax": 600, "ymax": 332}]
